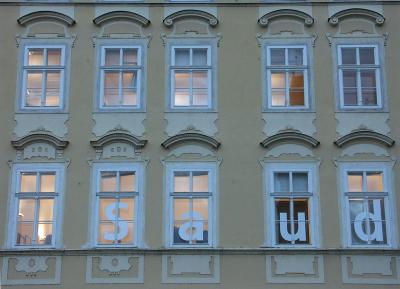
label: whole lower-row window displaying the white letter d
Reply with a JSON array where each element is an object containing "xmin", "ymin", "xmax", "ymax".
[{"xmin": 341, "ymin": 164, "xmax": 391, "ymax": 246}]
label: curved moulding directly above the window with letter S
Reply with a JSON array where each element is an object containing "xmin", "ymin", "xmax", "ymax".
[{"xmin": 90, "ymin": 130, "xmax": 147, "ymax": 150}]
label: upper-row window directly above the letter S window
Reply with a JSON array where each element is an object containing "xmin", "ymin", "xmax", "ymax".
[{"xmin": 100, "ymin": 46, "xmax": 143, "ymax": 108}]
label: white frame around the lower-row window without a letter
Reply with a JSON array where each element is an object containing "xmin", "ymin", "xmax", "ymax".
[{"xmin": 7, "ymin": 163, "xmax": 65, "ymax": 249}]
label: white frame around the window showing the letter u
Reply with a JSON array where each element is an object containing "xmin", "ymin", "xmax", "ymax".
[{"xmin": 264, "ymin": 162, "xmax": 320, "ymax": 248}]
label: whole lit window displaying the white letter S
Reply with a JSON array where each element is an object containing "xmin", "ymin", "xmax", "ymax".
[{"xmin": 95, "ymin": 164, "xmax": 142, "ymax": 246}]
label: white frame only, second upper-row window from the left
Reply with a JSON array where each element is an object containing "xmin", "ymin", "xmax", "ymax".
[{"xmin": 98, "ymin": 44, "xmax": 144, "ymax": 110}]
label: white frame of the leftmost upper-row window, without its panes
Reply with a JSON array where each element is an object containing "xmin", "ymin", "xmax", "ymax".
[{"xmin": 20, "ymin": 44, "xmax": 67, "ymax": 111}]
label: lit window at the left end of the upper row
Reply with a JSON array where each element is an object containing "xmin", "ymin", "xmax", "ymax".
[{"xmin": 21, "ymin": 46, "xmax": 65, "ymax": 109}]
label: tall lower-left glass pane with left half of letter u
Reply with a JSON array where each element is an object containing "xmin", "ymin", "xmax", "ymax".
[{"xmin": 275, "ymin": 199, "xmax": 292, "ymax": 244}]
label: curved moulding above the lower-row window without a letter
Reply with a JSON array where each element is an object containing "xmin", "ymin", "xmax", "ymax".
[{"xmin": 11, "ymin": 132, "xmax": 69, "ymax": 150}]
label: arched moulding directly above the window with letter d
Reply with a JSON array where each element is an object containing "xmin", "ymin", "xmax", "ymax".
[{"xmin": 334, "ymin": 129, "xmax": 394, "ymax": 147}]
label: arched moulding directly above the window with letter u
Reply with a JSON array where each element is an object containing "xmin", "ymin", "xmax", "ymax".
[{"xmin": 260, "ymin": 130, "xmax": 319, "ymax": 148}]
